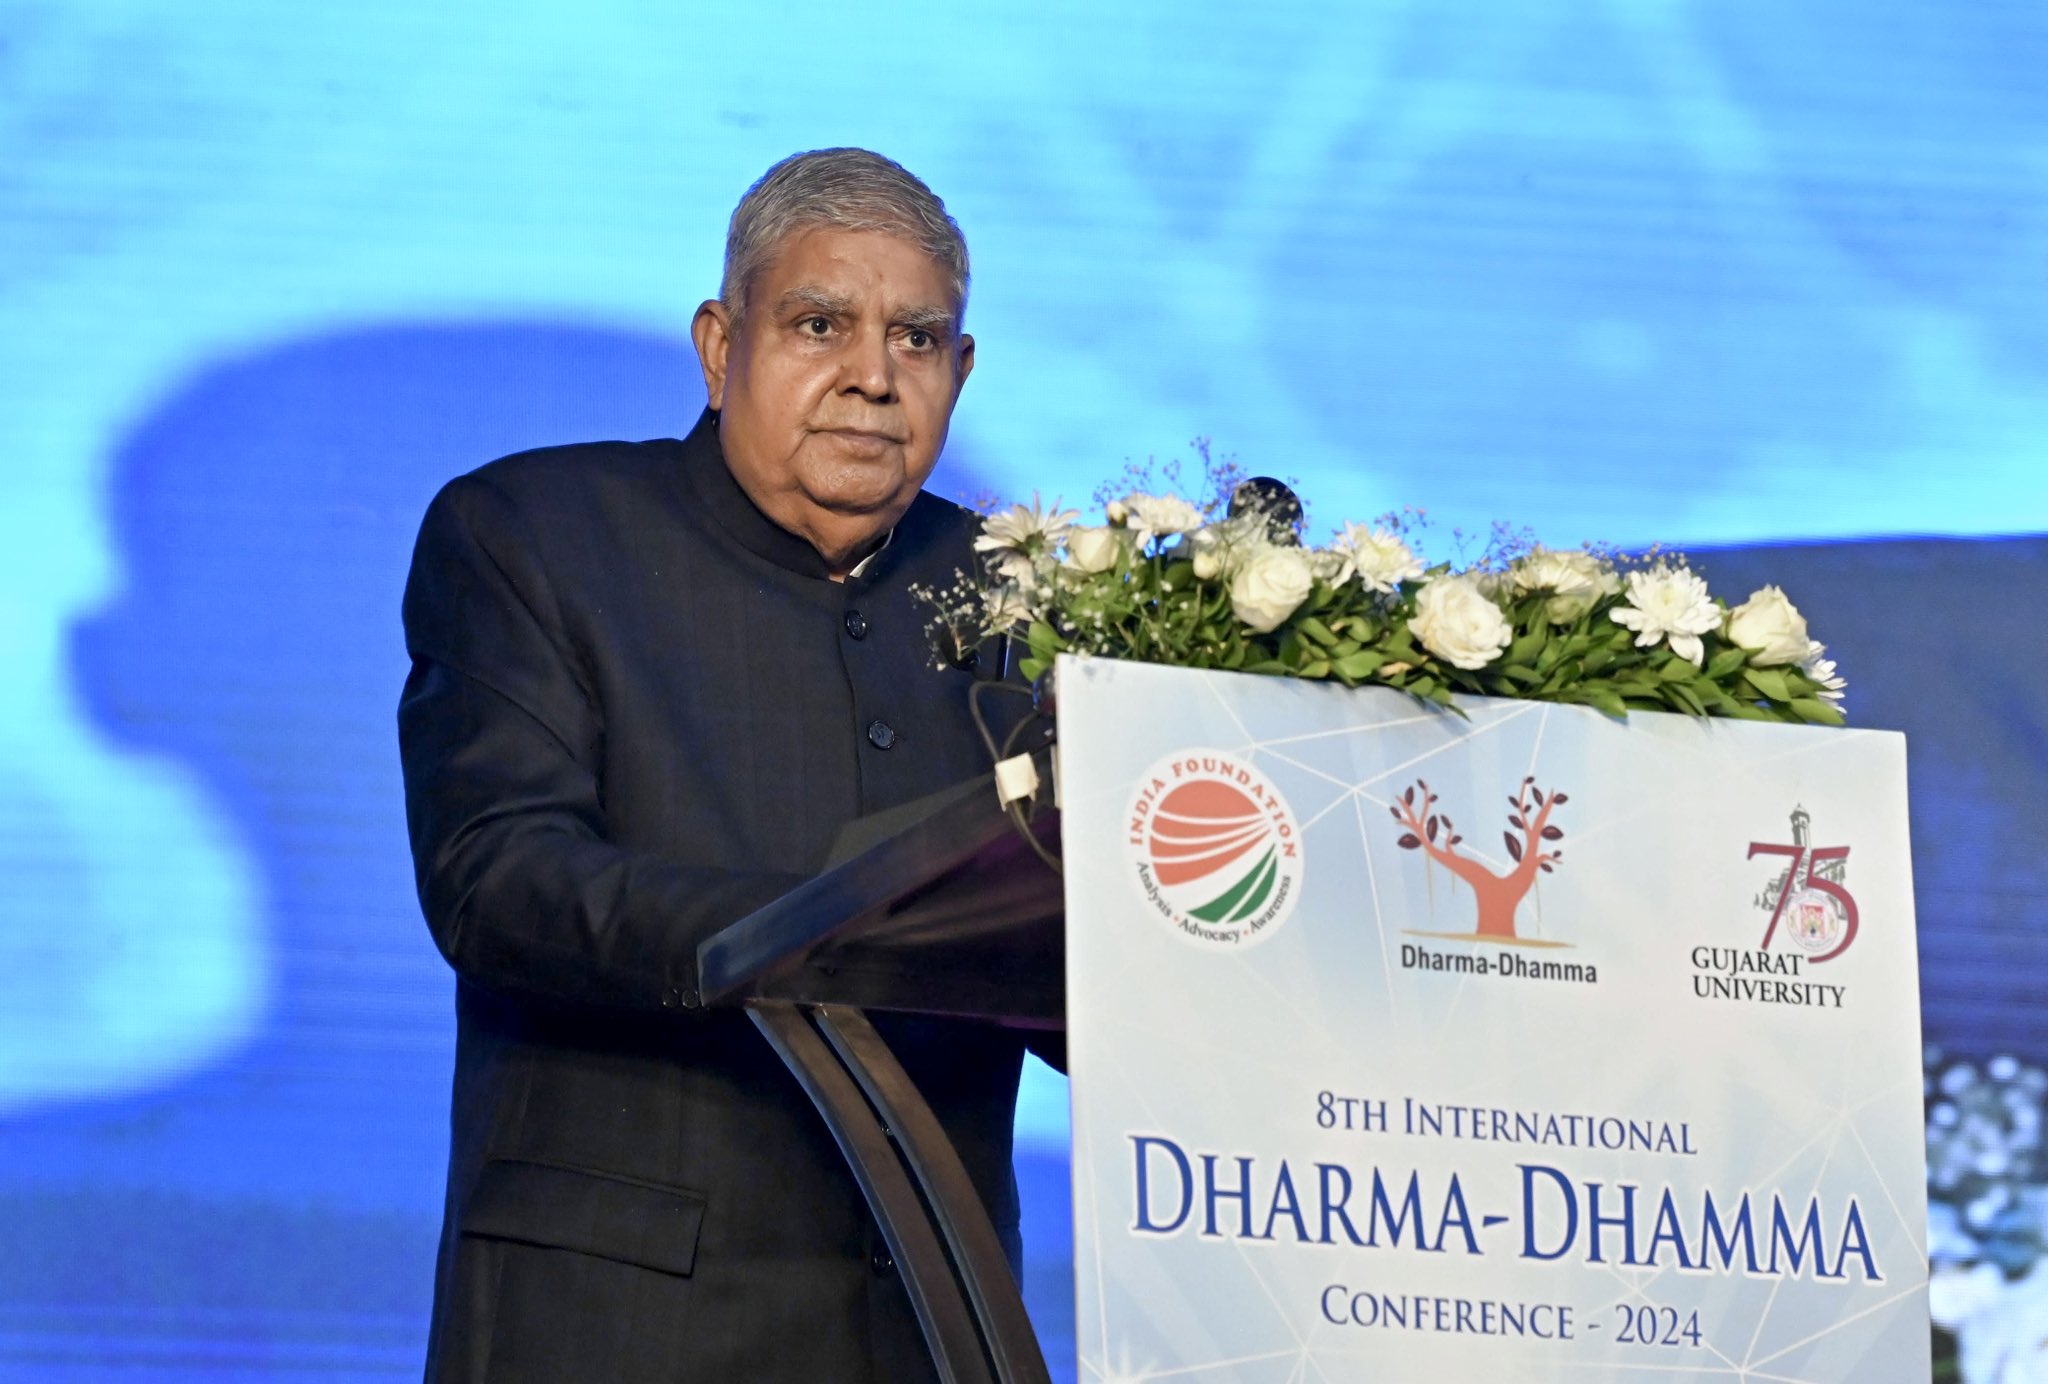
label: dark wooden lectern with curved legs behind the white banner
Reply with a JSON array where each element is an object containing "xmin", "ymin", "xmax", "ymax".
[{"xmin": 698, "ymin": 761, "xmax": 1065, "ymax": 1384}]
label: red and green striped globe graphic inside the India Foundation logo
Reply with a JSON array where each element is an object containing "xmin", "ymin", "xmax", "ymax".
[{"xmin": 1147, "ymin": 780, "xmax": 1280, "ymax": 923}]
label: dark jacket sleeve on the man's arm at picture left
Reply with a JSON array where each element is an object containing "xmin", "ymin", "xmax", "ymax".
[{"xmin": 397, "ymin": 475, "xmax": 801, "ymax": 1009}]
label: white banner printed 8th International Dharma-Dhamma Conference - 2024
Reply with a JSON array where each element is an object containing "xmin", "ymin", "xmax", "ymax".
[{"xmin": 1059, "ymin": 659, "xmax": 1929, "ymax": 1384}]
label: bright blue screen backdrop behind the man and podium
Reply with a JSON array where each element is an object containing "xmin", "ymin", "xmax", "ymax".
[{"xmin": 0, "ymin": 0, "xmax": 2048, "ymax": 1382}]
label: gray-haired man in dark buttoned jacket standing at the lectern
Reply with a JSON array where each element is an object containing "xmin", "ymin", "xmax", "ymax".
[{"xmin": 399, "ymin": 149, "xmax": 1022, "ymax": 1384}]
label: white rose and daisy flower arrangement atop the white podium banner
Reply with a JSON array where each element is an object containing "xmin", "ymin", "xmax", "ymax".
[{"xmin": 924, "ymin": 465, "xmax": 1843, "ymax": 725}]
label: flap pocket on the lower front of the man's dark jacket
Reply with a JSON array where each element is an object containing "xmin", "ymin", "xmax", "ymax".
[{"xmin": 463, "ymin": 1159, "xmax": 705, "ymax": 1275}]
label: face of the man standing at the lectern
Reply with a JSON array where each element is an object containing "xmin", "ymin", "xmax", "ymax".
[{"xmin": 692, "ymin": 227, "xmax": 975, "ymax": 573}]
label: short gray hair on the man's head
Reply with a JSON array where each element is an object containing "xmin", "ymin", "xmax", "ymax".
[{"xmin": 719, "ymin": 149, "xmax": 967, "ymax": 321}]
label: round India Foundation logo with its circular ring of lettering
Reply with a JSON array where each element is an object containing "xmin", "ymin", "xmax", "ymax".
[{"xmin": 1124, "ymin": 749, "xmax": 1300, "ymax": 946}]
